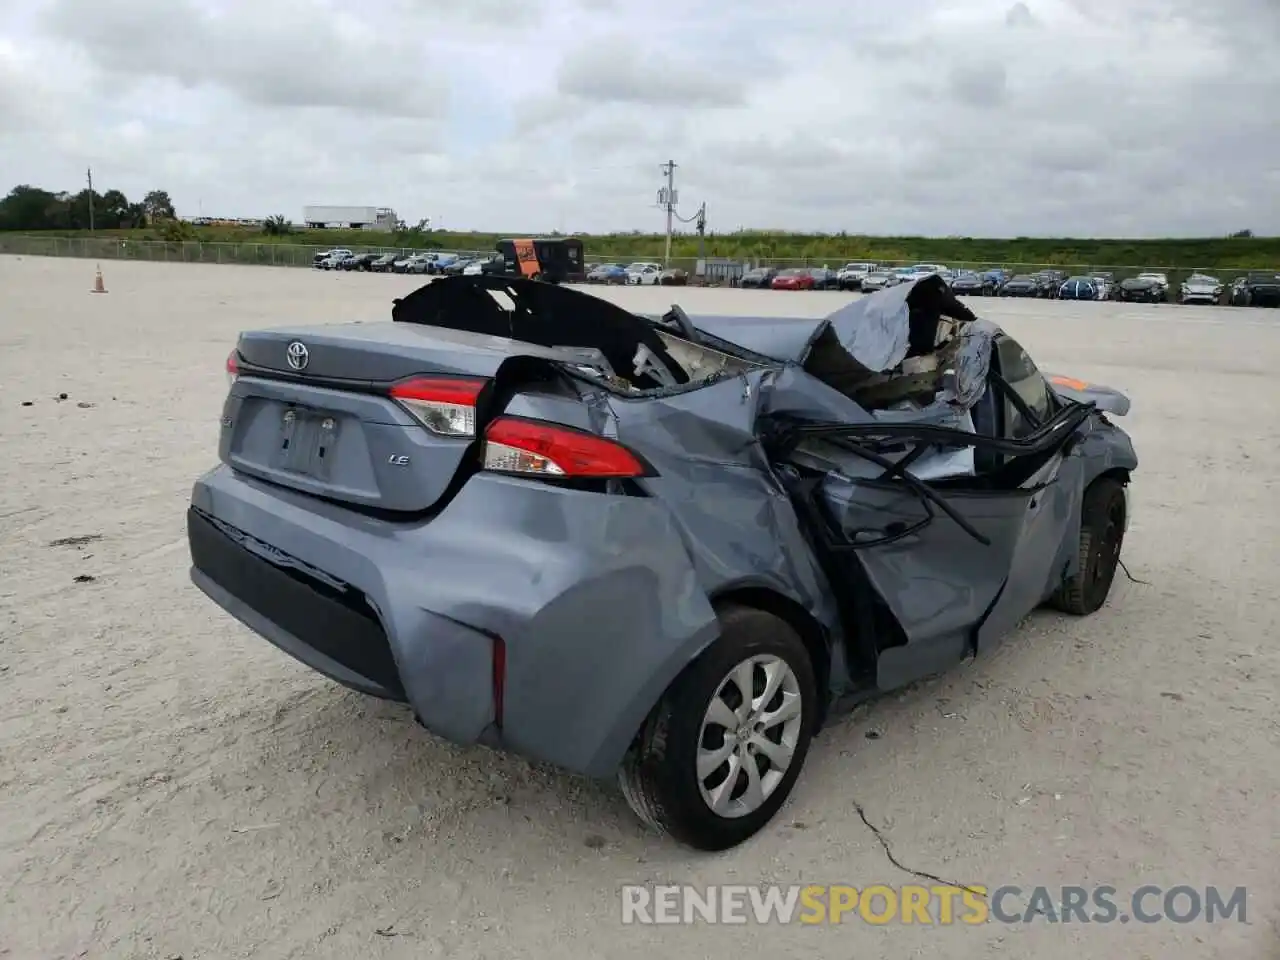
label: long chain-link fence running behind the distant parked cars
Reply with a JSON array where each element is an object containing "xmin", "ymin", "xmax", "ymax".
[{"xmin": 0, "ymin": 234, "xmax": 1243, "ymax": 289}]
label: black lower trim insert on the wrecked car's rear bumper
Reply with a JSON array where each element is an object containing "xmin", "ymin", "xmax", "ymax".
[{"xmin": 187, "ymin": 507, "xmax": 406, "ymax": 700}]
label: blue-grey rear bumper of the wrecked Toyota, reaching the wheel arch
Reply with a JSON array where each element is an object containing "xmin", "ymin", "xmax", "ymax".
[{"xmin": 188, "ymin": 466, "xmax": 717, "ymax": 776}]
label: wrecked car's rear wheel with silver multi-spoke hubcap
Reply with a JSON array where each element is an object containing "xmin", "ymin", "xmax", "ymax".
[{"xmin": 618, "ymin": 607, "xmax": 818, "ymax": 850}]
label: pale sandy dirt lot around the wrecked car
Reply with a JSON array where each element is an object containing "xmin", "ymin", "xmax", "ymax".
[{"xmin": 0, "ymin": 257, "xmax": 1280, "ymax": 960}]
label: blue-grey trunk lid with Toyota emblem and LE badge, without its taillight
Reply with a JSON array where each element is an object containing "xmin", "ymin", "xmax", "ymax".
[{"xmin": 219, "ymin": 323, "xmax": 616, "ymax": 512}]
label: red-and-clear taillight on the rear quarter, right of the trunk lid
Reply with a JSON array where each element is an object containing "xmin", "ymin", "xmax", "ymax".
[{"xmin": 484, "ymin": 417, "xmax": 648, "ymax": 479}]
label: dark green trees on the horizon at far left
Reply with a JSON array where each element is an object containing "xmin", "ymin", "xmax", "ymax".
[{"xmin": 0, "ymin": 183, "xmax": 177, "ymax": 230}]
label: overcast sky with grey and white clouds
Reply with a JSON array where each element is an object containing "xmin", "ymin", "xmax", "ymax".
[{"xmin": 0, "ymin": 0, "xmax": 1280, "ymax": 237}]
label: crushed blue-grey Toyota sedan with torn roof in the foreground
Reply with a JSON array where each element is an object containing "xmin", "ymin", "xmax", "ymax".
[{"xmin": 187, "ymin": 276, "xmax": 1138, "ymax": 850}]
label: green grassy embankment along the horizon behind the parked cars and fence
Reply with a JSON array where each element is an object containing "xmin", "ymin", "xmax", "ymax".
[{"xmin": 0, "ymin": 227, "xmax": 1280, "ymax": 271}]
